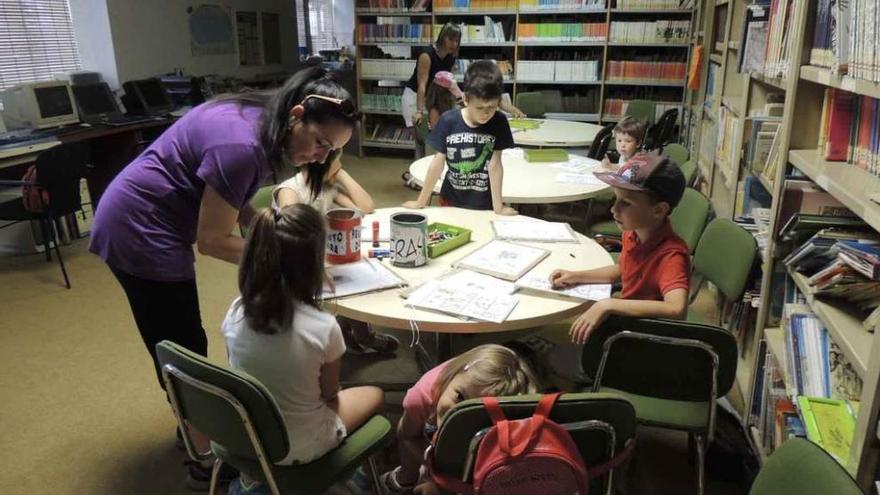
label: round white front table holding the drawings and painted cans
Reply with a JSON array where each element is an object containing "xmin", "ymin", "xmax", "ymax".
[{"xmin": 325, "ymin": 207, "xmax": 613, "ymax": 335}]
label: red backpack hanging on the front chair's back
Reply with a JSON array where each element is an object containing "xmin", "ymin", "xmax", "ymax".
[{"xmin": 431, "ymin": 393, "xmax": 635, "ymax": 495}]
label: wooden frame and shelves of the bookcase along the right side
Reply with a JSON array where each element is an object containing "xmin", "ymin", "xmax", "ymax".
[{"xmin": 691, "ymin": 0, "xmax": 880, "ymax": 492}]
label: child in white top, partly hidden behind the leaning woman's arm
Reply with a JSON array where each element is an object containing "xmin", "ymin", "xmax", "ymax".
[{"xmin": 272, "ymin": 159, "xmax": 376, "ymax": 214}]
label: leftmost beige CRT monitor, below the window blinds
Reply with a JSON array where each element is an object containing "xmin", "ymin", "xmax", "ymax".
[{"xmin": 0, "ymin": 81, "xmax": 79, "ymax": 129}]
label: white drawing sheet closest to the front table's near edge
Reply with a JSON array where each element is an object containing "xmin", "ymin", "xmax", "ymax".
[{"xmin": 406, "ymin": 280, "xmax": 519, "ymax": 323}]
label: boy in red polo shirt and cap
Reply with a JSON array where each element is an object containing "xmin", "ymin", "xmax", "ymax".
[{"xmin": 550, "ymin": 153, "xmax": 691, "ymax": 344}]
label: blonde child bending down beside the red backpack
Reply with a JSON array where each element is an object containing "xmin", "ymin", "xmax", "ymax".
[{"xmin": 380, "ymin": 344, "xmax": 539, "ymax": 493}]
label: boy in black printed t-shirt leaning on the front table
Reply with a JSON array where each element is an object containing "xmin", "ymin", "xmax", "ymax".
[{"xmin": 403, "ymin": 60, "xmax": 517, "ymax": 215}]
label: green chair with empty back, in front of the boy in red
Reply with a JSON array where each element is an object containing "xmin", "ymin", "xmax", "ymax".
[{"xmin": 581, "ymin": 317, "xmax": 737, "ymax": 494}]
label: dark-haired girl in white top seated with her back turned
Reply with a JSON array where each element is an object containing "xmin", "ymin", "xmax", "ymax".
[{"xmin": 222, "ymin": 204, "xmax": 383, "ymax": 476}]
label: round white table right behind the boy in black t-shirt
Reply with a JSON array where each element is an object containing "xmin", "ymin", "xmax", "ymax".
[{"xmin": 409, "ymin": 148, "xmax": 609, "ymax": 204}]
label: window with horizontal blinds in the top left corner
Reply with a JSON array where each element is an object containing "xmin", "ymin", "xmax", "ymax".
[{"xmin": 0, "ymin": 0, "xmax": 80, "ymax": 89}]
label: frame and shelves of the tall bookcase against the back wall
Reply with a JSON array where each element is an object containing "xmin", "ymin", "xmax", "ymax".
[{"xmin": 355, "ymin": 0, "xmax": 695, "ymax": 154}]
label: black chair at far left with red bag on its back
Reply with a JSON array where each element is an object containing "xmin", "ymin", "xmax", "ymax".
[{"xmin": 0, "ymin": 143, "xmax": 89, "ymax": 289}]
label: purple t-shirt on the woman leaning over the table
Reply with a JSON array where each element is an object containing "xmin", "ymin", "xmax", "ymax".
[{"xmin": 89, "ymin": 103, "xmax": 272, "ymax": 281}]
